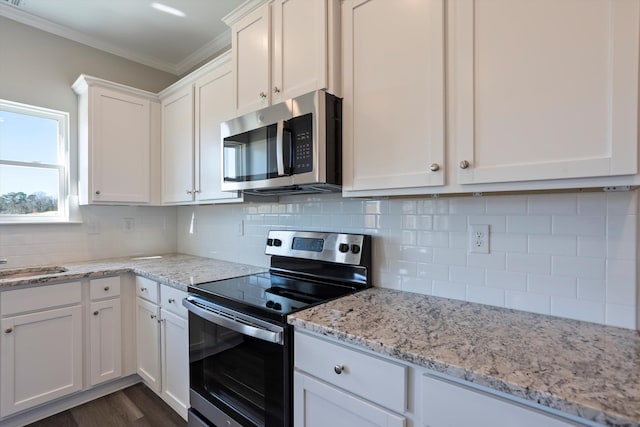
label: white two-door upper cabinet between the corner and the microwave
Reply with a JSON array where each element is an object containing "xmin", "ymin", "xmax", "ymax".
[{"xmin": 160, "ymin": 53, "xmax": 242, "ymax": 204}]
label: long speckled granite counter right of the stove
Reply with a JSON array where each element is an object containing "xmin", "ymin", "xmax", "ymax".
[{"xmin": 289, "ymin": 288, "xmax": 640, "ymax": 427}]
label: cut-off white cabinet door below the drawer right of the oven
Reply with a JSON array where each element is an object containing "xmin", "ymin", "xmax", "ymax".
[{"xmin": 293, "ymin": 372, "xmax": 406, "ymax": 427}]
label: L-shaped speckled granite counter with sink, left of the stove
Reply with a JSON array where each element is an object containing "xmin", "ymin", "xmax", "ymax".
[{"xmin": 0, "ymin": 254, "xmax": 266, "ymax": 290}]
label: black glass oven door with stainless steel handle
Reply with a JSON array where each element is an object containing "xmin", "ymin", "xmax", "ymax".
[{"xmin": 183, "ymin": 295, "xmax": 291, "ymax": 427}]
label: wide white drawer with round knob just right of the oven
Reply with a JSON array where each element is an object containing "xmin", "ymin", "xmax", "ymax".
[{"xmin": 294, "ymin": 332, "xmax": 407, "ymax": 413}]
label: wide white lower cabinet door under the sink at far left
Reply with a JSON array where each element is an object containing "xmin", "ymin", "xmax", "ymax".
[{"xmin": 0, "ymin": 305, "xmax": 82, "ymax": 417}]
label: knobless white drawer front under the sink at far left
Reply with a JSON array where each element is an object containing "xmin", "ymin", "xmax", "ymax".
[{"xmin": 0, "ymin": 282, "xmax": 82, "ymax": 316}]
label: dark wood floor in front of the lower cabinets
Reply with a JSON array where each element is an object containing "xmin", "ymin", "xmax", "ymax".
[{"xmin": 27, "ymin": 383, "xmax": 187, "ymax": 427}]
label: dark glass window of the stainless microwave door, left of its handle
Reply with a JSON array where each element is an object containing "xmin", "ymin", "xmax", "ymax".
[{"xmin": 223, "ymin": 124, "xmax": 278, "ymax": 182}]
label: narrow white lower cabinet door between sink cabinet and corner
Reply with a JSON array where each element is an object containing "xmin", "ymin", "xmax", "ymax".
[{"xmin": 89, "ymin": 298, "xmax": 122, "ymax": 385}]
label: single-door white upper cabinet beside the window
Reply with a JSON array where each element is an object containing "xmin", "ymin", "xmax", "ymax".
[{"xmin": 73, "ymin": 75, "xmax": 160, "ymax": 205}]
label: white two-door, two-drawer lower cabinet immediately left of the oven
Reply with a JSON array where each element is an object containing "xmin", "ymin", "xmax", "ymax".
[{"xmin": 136, "ymin": 277, "xmax": 189, "ymax": 419}]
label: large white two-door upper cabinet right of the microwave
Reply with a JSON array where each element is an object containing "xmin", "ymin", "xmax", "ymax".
[{"xmin": 342, "ymin": 0, "xmax": 640, "ymax": 196}]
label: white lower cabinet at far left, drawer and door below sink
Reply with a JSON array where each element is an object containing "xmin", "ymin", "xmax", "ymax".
[{"xmin": 0, "ymin": 282, "xmax": 83, "ymax": 417}]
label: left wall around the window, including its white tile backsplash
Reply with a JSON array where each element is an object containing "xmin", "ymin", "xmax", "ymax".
[{"xmin": 0, "ymin": 17, "xmax": 177, "ymax": 267}]
